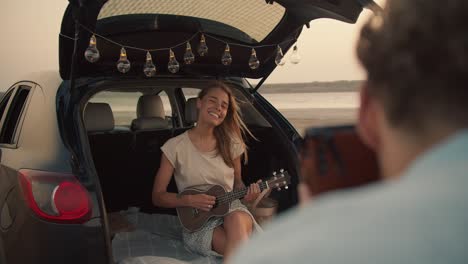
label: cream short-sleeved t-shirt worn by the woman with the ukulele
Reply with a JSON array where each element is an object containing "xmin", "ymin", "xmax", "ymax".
[{"xmin": 161, "ymin": 131, "xmax": 244, "ymax": 192}]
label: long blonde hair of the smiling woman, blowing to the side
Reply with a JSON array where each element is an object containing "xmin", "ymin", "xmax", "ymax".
[{"xmin": 198, "ymin": 81, "xmax": 255, "ymax": 168}]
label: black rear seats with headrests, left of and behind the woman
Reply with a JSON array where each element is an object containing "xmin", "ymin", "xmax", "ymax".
[{"xmin": 84, "ymin": 95, "xmax": 229, "ymax": 214}]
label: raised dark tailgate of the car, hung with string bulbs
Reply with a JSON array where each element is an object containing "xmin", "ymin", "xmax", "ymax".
[{"xmin": 59, "ymin": 0, "xmax": 380, "ymax": 80}]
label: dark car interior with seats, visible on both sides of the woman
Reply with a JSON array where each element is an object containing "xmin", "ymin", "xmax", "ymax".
[{"xmin": 84, "ymin": 81, "xmax": 293, "ymax": 221}]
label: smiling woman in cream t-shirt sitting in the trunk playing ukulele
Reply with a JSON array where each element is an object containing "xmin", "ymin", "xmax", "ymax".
[{"xmin": 153, "ymin": 82, "xmax": 260, "ymax": 259}]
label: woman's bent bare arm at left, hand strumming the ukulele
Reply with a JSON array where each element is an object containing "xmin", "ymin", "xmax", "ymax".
[{"xmin": 152, "ymin": 153, "xmax": 215, "ymax": 211}]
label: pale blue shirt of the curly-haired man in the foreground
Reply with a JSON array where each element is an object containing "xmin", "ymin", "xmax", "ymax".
[{"xmin": 231, "ymin": 131, "xmax": 468, "ymax": 264}]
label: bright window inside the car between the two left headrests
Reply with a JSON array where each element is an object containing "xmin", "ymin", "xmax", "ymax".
[{"xmin": 89, "ymin": 91, "xmax": 142, "ymax": 127}]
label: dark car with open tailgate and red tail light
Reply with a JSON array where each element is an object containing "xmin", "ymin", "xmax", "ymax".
[{"xmin": 0, "ymin": 0, "xmax": 376, "ymax": 264}]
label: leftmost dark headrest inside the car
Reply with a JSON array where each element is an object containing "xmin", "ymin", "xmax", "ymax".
[{"xmin": 84, "ymin": 103, "xmax": 114, "ymax": 132}]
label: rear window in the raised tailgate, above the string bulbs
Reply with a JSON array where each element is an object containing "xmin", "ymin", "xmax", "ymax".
[{"xmin": 98, "ymin": 0, "xmax": 286, "ymax": 42}]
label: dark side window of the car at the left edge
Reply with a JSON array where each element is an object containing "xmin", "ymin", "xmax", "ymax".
[{"xmin": 0, "ymin": 85, "xmax": 31, "ymax": 144}]
